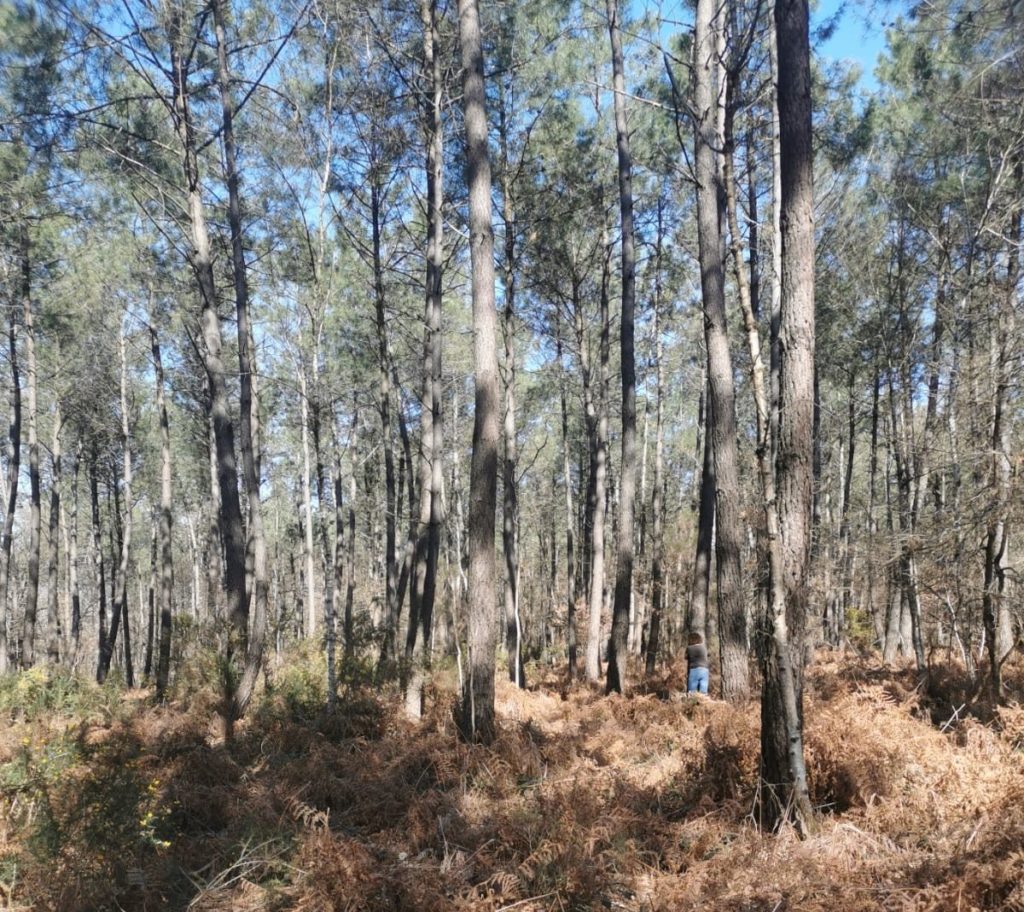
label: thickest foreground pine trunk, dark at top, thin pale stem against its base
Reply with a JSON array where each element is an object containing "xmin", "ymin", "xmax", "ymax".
[{"xmin": 761, "ymin": 0, "xmax": 815, "ymax": 833}]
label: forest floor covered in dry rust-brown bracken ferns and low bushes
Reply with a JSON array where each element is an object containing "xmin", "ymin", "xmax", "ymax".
[{"xmin": 0, "ymin": 653, "xmax": 1024, "ymax": 912}]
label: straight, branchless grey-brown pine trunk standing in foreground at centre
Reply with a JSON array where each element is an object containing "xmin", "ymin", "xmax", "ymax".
[{"xmin": 459, "ymin": 0, "xmax": 501, "ymax": 743}]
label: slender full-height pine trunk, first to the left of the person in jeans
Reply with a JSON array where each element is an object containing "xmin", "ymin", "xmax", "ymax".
[{"xmin": 605, "ymin": 0, "xmax": 637, "ymax": 693}]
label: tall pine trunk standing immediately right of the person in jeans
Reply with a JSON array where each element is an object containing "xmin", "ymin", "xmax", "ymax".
[{"xmin": 694, "ymin": 0, "xmax": 750, "ymax": 700}]
